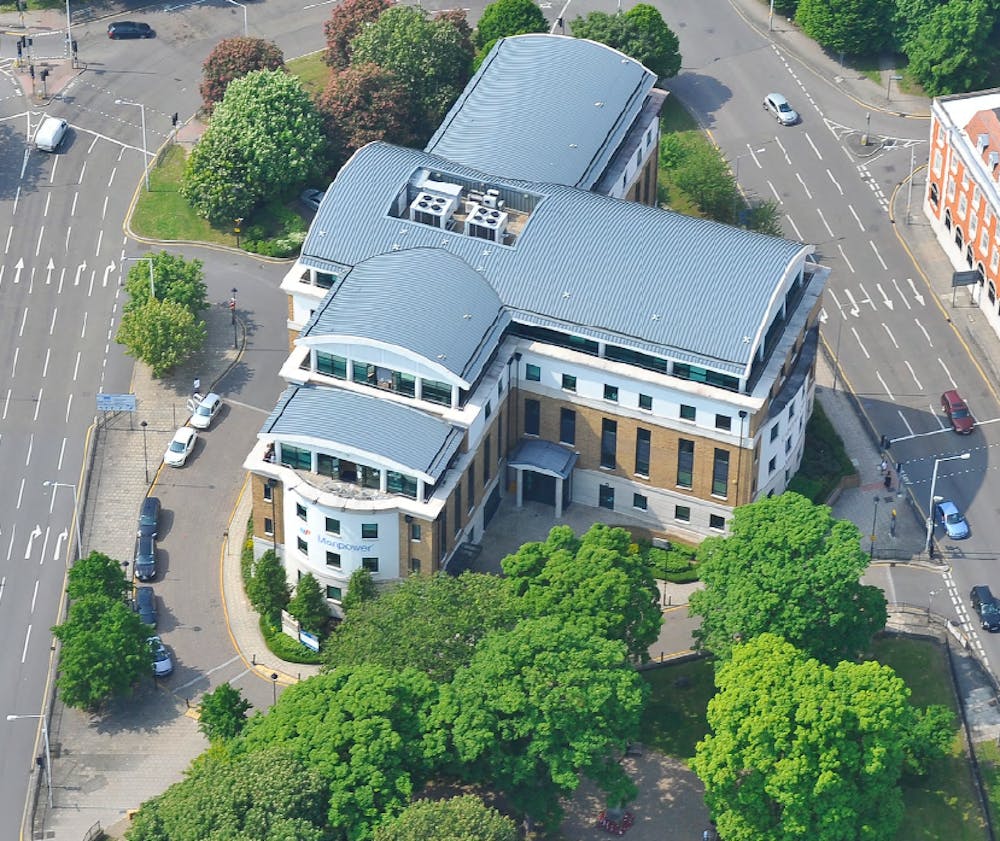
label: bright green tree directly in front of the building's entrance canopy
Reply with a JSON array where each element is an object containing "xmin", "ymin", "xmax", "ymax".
[{"xmin": 501, "ymin": 523, "xmax": 663, "ymax": 661}]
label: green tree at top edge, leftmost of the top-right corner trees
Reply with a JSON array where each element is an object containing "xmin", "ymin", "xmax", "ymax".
[{"xmin": 795, "ymin": 0, "xmax": 896, "ymax": 55}]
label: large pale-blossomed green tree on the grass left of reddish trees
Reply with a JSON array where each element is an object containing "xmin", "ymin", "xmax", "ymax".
[{"xmin": 181, "ymin": 70, "xmax": 326, "ymax": 226}]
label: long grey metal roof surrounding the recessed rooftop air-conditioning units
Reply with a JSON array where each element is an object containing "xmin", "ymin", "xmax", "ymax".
[{"xmin": 302, "ymin": 143, "xmax": 805, "ymax": 371}]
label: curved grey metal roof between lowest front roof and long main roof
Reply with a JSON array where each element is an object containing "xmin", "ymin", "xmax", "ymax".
[{"xmin": 301, "ymin": 248, "xmax": 510, "ymax": 385}]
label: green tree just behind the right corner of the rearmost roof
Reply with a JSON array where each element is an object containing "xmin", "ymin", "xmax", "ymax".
[{"xmin": 570, "ymin": 3, "xmax": 681, "ymax": 79}]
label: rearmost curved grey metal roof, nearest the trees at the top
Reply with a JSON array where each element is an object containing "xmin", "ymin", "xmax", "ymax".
[{"xmin": 424, "ymin": 34, "xmax": 656, "ymax": 190}]
